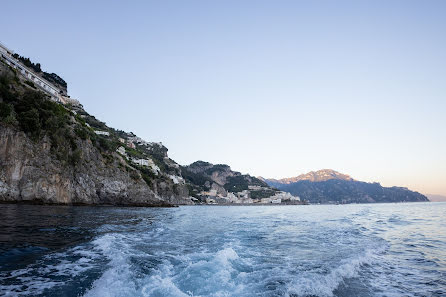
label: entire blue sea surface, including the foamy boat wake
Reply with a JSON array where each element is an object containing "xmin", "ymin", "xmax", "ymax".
[{"xmin": 0, "ymin": 203, "xmax": 446, "ymax": 297}]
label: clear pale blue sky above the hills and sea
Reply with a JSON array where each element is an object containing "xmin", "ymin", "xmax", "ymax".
[{"xmin": 0, "ymin": 0, "xmax": 446, "ymax": 195}]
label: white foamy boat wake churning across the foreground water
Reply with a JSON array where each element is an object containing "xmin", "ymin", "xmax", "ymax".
[{"xmin": 84, "ymin": 227, "xmax": 385, "ymax": 297}]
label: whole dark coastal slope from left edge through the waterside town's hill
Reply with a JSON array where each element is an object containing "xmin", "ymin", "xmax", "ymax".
[{"xmin": 0, "ymin": 48, "xmax": 300, "ymax": 206}]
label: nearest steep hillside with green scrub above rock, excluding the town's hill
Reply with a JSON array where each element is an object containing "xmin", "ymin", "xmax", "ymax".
[{"xmin": 0, "ymin": 54, "xmax": 191, "ymax": 206}]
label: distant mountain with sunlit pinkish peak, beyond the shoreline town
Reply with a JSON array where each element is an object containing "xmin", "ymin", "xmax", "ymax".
[{"xmin": 259, "ymin": 169, "xmax": 429, "ymax": 203}]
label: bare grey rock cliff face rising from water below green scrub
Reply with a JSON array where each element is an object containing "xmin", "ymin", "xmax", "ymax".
[{"xmin": 0, "ymin": 125, "xmax": 189, "ymax": 206}]
